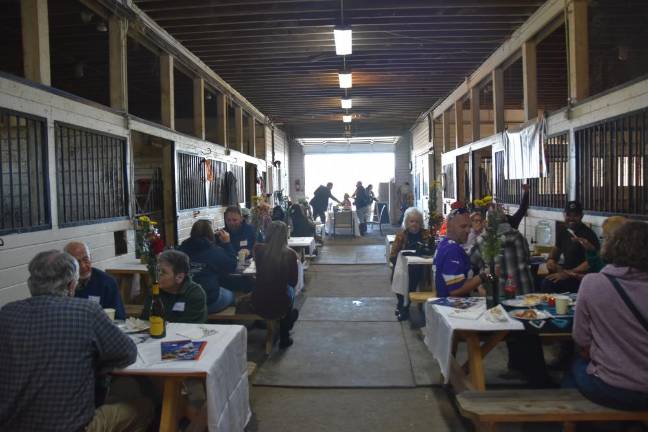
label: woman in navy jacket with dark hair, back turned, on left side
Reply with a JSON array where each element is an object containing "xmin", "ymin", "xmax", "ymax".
[{"xmin": 180, "ymin": 219, "xmax": 236, "ymax": 313}]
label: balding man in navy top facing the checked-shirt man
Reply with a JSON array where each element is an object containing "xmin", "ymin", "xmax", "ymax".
[{"xmin": 63, "ymin": 241, "xmax": 126, "ymax": 319}]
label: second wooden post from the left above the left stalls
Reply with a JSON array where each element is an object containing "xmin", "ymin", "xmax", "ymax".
[{"xmin": 108, "ymin": 16, "xmax": 128, "ymax": 111}]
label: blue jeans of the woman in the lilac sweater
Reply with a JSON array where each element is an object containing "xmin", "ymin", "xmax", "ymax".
[{"xmin": 563, "ymin": 358, "xmax": 648, "ymax": 411}]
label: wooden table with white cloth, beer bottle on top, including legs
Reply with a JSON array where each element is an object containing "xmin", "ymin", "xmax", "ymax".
[{"xmin": 114, "ymin": 323, "xmax": 251, "ymax": 432}]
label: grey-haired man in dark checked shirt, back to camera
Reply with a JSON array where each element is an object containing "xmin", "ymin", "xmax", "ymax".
[{"xmin": 0, "ymin": 250, "xmax": 153, "ymax": 432}]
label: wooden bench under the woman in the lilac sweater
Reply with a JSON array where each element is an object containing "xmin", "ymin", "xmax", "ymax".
[{"xmin": 457, "ymin": 389, "xmax": 648, "ymax": 432}]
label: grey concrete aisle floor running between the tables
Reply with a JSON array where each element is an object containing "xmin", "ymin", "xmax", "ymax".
[{"xmin": 247, "ymin": 236, "xmax": 467, "ymax": 432}]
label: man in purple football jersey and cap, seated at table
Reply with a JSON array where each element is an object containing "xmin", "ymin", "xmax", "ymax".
[{"xmin": 433, "ymin": 208, "xmax": 487, "ymax": 297}]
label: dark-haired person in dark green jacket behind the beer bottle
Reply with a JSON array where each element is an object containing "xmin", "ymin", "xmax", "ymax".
[{"xmin": 142, "ymin": 249, "xmax": 207, "ymax": 323}]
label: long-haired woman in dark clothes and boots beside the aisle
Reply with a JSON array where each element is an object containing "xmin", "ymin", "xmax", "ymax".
[{"xmin": 252, "ymin": 221, "xmax": 299, "ymax": 348}]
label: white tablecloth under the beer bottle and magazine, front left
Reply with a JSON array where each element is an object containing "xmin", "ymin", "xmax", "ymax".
[{"xmin": 125, "ymin": 323, "xmax": 252, "ymax": 432}]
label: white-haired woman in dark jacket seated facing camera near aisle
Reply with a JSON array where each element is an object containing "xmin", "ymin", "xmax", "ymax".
[{"xmin": 389, "ymin": 207, "xmax": 434, "ymax": 321}]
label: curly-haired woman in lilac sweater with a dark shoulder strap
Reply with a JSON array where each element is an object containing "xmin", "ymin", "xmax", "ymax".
[{"xmin": 572, "ymin": 221, "xmax": 648, "ymax": 410}]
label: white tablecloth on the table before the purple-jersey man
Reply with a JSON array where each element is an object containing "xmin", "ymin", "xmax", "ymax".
[{"xmin": 423, "ymin": 299, "xmax": 524, "ymax": 384}]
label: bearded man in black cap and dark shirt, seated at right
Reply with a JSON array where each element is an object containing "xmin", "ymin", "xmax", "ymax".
[{"xmin": 541, "ymin": 201, "xmax": 600, "ymax": 293}]
